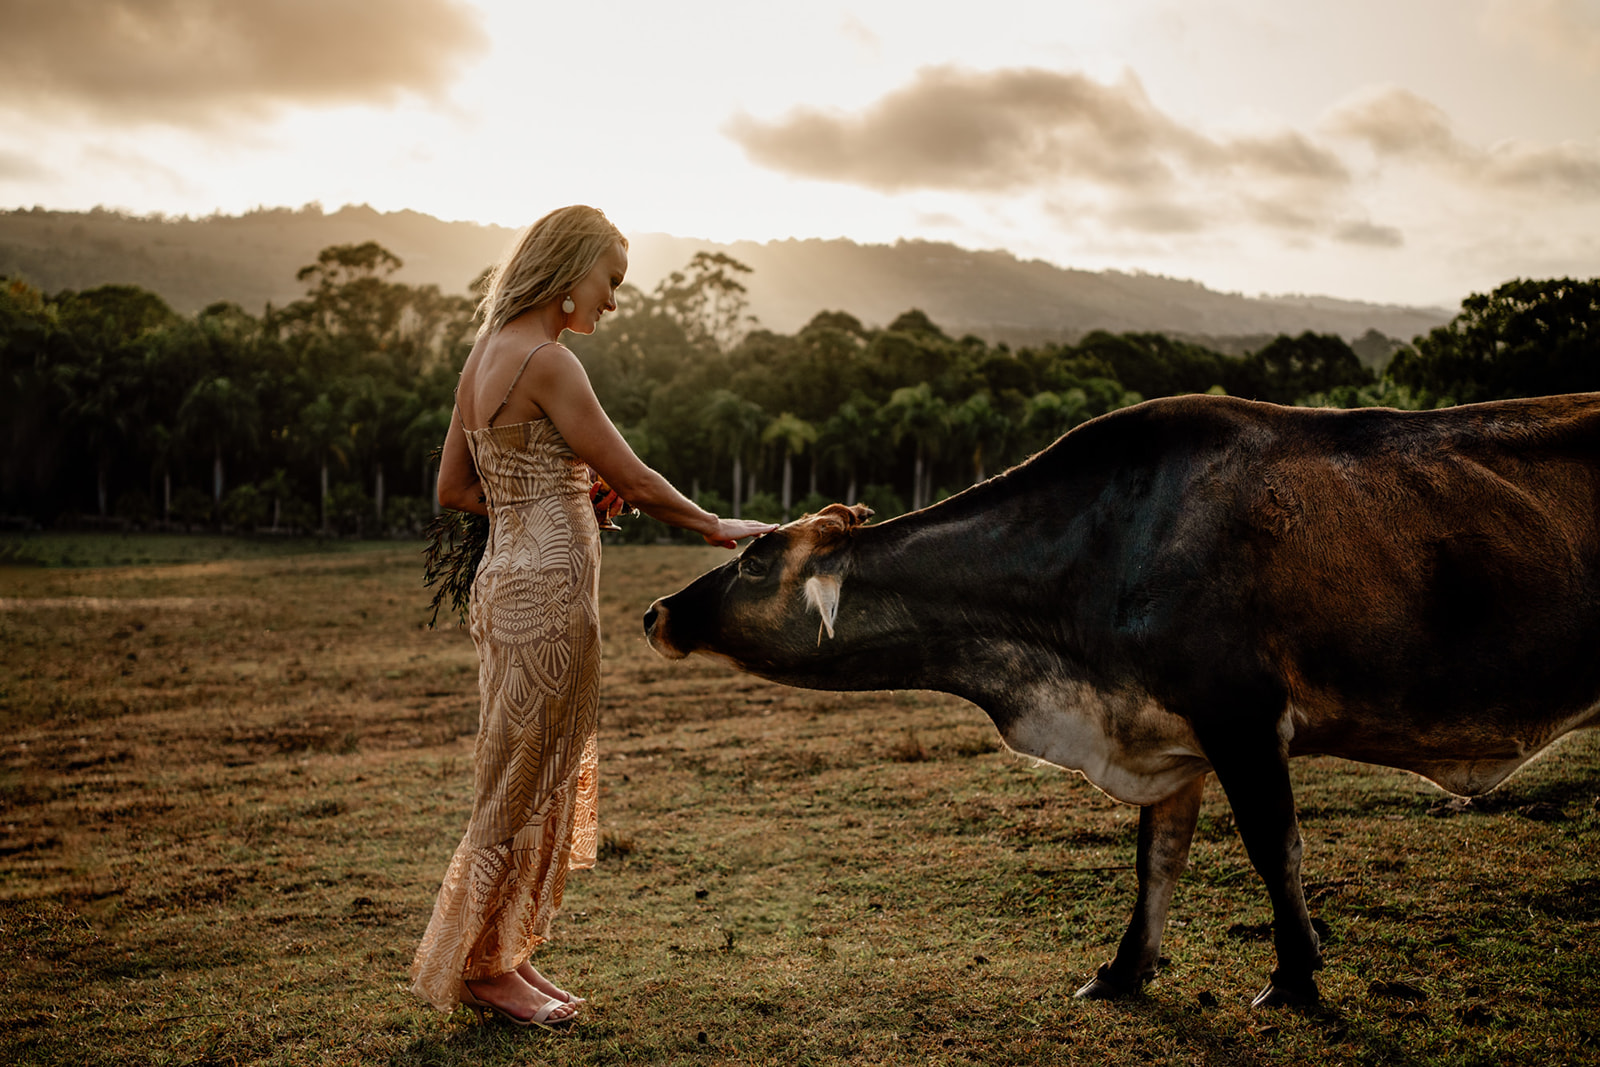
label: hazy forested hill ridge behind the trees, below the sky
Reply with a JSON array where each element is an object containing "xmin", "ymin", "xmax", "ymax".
[{"xmin": 0, "ymin": 206, "xmax": 1453, "ymax": 350}]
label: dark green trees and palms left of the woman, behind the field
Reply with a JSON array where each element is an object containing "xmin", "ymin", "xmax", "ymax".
[{"xmin": 0, "ymin": 243, "xmax": 470, "ymax": 528}]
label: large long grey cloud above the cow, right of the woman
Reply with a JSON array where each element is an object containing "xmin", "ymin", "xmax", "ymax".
[{"xmin": 723, "ymin": 67, "xmax": 1352, "ymax": 244}]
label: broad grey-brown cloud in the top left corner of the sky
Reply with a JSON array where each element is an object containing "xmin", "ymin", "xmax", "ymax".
[{"xmin": 0, "ymin": 0, "xmax": 488, "ymax": 125}]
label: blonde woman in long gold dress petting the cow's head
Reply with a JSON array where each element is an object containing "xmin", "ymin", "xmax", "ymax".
[{"xmin": 411, "ymin": 206, "xmax": 773, "ymax": 1025}]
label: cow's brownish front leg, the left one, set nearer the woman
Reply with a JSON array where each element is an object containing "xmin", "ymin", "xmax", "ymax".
[{"xmin": 1077, "ymin": 774, "xmax": 1205, "ymax": 1000}]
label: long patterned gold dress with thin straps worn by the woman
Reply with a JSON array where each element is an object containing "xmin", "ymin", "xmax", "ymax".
[{"xmin": 411, "ymin": 412, "xmax": 600, "ymax": 1011}]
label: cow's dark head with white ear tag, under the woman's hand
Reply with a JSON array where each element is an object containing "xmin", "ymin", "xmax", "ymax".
[{"xmin": 645, "ymin": 504, "xmax": 872, "ymax": 678}]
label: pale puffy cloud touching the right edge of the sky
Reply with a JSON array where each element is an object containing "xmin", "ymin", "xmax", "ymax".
[{"xmin": 1323, "ymin": 85, "xmax": 1600, "ymax": 200}]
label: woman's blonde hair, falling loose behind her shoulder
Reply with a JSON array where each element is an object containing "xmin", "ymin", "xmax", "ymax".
[{"xmin": 478, "ymin": 203, "xmax": 627, "ymax": 334}]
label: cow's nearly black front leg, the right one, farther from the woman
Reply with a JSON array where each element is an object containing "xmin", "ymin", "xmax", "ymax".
[{"xmin": 1197, "ymin": 716, "xmax": 1322, "ymax": 1008}]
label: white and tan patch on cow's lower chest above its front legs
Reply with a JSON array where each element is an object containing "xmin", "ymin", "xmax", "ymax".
[{"xmin": 1002, "ymin": 681, "xmax": 1211, "ymax": 805}]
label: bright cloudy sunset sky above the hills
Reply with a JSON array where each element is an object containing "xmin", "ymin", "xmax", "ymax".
[{"xmin": 0, "ymin": 0, "xmax": 1600, "ymax": 309}]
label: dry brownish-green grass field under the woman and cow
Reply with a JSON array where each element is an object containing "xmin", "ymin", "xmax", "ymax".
[{"xmin": 0, "ymin": 536, "xmax": 1600, "ymax": 1067}]
